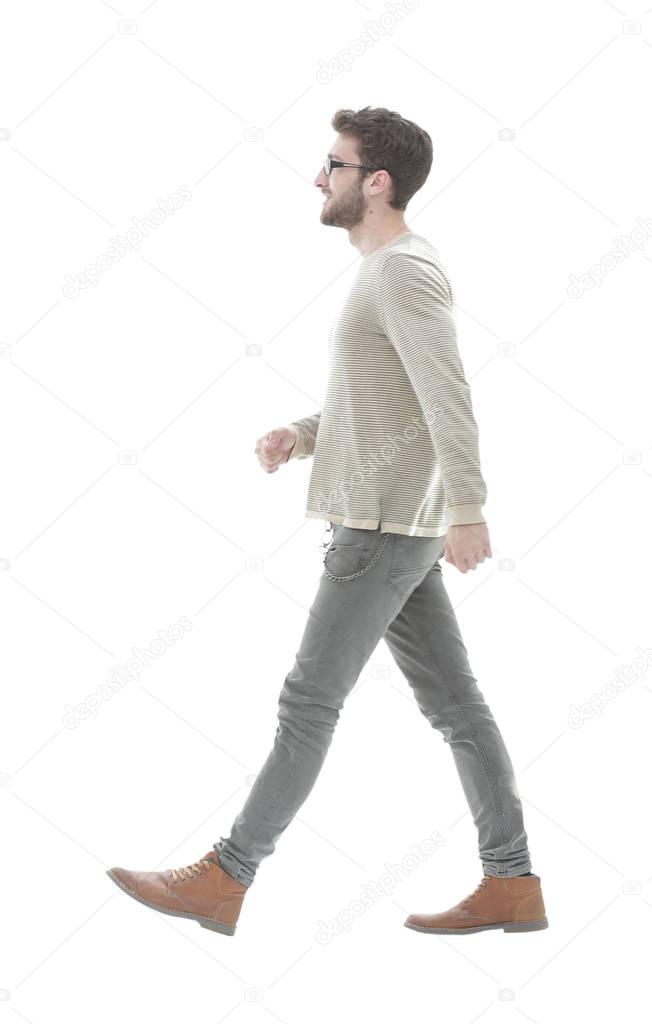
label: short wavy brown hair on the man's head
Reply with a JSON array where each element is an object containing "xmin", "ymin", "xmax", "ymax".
[{"xmin": 331, "ymin": 106, "xmax": 432, "ymax": 210}]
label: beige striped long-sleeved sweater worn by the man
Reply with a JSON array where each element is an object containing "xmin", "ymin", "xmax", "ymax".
[{"xmin": 289, "ymin": 231, "xmax": 486, "ymax": 537}]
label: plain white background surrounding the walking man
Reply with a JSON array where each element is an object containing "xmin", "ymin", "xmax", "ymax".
[{"xmin": 0, "ymin": 0, "xmax": 652, "ymax": 1024}]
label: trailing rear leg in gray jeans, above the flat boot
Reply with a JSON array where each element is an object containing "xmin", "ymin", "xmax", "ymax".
[{"xmin": 385, "ymin": 561, "xmax": 531, "ymax": 878}]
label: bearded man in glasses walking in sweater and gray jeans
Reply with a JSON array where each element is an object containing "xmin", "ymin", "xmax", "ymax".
[{"xmin": 108, "ymin": 106, "xmax": 548, "ymax": 935}]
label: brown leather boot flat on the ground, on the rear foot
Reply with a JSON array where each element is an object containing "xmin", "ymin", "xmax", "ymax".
[{"xmin": 403, "ymin": 874, "xmax": 548, "ymax": 935}]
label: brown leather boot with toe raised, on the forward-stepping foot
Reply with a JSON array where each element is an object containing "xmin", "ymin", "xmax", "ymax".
[{"xmin": 106, "ymin": 849, "xmax": 247, "ymax": 935}]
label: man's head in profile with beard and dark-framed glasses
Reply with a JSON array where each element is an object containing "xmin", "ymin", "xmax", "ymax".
[{"xmin": 314, "ymin": 106, "xmax": 433, "ymax": 228}]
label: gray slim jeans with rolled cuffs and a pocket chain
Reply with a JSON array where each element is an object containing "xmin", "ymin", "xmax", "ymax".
[{"xmin": 214, "ymin": 523, "xmax": 531, "ymax": 886}]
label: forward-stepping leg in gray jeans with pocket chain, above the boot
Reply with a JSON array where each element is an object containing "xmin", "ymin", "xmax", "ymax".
[{"xmin": 214, "ymin": 524, "xmax": 417, "ymax": 886}]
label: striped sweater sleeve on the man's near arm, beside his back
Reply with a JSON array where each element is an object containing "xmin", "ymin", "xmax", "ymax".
[{"xmin": 378, "ymin": 253, "xmax": 487, "ymax": 525}]
